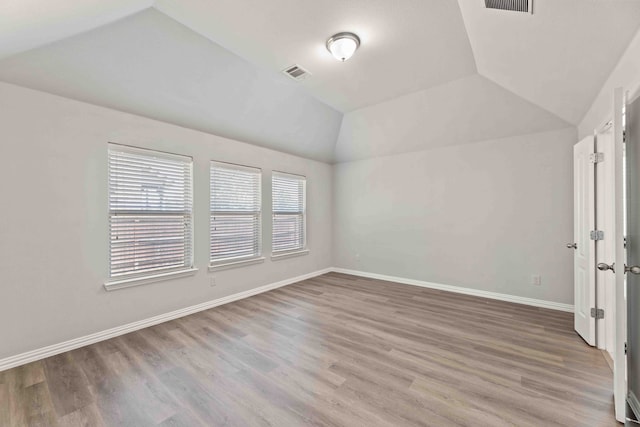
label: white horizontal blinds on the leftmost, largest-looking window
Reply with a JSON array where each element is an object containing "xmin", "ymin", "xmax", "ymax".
[{"xmin": 109, "ymin": 144, "xmax": 193, "ymax": 280}]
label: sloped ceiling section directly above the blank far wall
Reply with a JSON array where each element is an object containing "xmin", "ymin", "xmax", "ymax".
[{"xmin": 335, "ymin": 74, "xmax": 571, "ymax": 162}]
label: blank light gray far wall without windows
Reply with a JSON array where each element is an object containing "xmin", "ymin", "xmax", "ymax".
[{"xmin": 333, "ymin": 128, "xmax": 577, "ymax": 304}]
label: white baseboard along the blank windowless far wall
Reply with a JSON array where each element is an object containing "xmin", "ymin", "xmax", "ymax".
[{"xmin": 331, "ymin": 267, "xmax": 573, "ymax": 313}]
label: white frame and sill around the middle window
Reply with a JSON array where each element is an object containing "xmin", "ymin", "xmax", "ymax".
[{"xmin": 208, "ymin": 160, "xmax": 265, "ymax": 272}]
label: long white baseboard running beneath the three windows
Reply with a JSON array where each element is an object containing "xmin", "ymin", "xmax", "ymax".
[{"xmin": 0, "ymin": 268, "xmax": 333, "ymax": 371}]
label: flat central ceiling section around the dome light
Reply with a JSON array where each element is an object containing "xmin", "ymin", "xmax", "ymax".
[{"xmin": 156, "ymin": 0, "xmax": 476, "ymax": 111}]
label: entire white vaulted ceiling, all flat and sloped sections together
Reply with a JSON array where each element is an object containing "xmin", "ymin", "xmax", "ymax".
[{"xmin": 0, "ymin": 0, "xmax": 640, "ymax": 161}]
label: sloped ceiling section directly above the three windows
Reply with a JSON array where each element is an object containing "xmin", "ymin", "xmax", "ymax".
[{"xmin": 0, "ymin": 9, "xmax": 342, "ymax": 162}]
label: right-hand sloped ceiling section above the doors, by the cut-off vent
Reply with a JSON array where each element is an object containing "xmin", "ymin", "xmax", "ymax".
[{"xmin": 458, "ymin": 0, "xmax": 640, "ymax": 125}]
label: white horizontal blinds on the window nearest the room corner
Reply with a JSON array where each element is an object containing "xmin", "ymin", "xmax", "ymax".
[{"xmin": 271, "ymin": 172, "xmax": 306, "ymax": 254}]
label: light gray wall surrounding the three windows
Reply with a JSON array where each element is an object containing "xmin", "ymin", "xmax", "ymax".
[{"xmin": 0, "ymin": 83, "xmax": 332, "ymax": 358}]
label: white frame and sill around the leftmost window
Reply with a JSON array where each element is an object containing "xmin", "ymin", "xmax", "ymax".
[{"xmin": 103, "ymin": 145, "xmax": 198, "ymax": 291}]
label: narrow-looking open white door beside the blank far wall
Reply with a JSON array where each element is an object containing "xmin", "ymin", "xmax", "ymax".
[{"xmin": 573, "ymin": 136, "xmax": 596, "ymax": 346}]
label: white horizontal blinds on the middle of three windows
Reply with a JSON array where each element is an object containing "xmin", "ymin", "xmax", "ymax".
[{"xmin": 210, "ymin": 162, "xmax": 262, "ymax": 266}]
